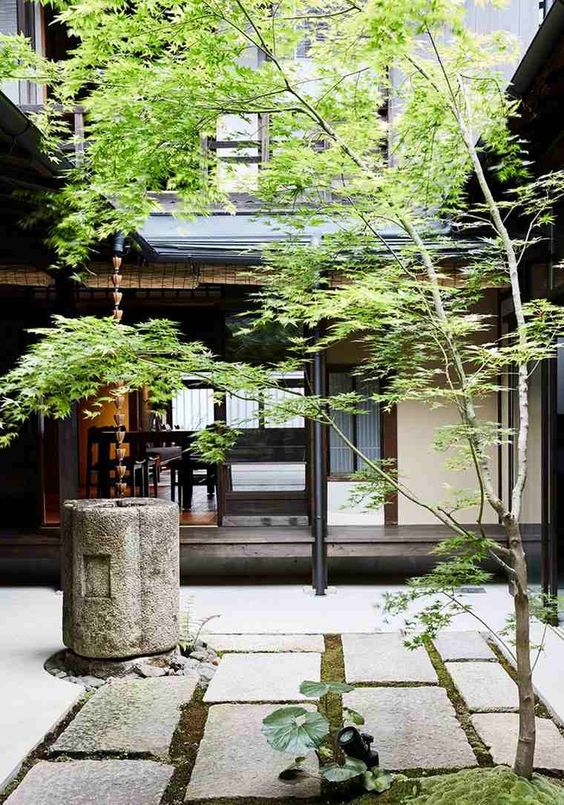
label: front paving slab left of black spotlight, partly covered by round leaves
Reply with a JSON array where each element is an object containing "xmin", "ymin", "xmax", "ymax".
[{"xmin": 186, "ymin": 704, "xmax": 320, "ymax": 802}]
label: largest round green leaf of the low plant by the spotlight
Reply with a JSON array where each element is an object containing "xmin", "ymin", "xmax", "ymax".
[{"xmin": 262, "ymin": 707, "xmax": 329, "ymax": 755}]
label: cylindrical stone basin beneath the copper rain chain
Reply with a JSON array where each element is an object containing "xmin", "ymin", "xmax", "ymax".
[{"xmin": 61, "ymin": 498, "xmax": 179, "ymax": 659}]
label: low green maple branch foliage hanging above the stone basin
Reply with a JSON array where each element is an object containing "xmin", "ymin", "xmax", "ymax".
[{"xmin": 0, "ymin": 316, "xmax": 271, "ymax": 450}]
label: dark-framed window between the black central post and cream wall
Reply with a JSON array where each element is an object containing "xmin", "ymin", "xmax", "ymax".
[{"xmin": 329, "ymin": 369, "xmax": 381, "ymax": 476}]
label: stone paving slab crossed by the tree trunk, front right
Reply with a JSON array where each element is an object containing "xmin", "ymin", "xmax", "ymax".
[{"xmin": 472, "ymin": 713, "xmax": 564, "ymax": 771}]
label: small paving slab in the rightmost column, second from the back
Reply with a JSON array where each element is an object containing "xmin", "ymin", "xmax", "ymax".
[{"xmin": 446, "ymin": 662, "xmax": 519, "ymax": 713}]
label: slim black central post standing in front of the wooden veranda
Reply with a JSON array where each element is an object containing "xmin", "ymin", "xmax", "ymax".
[{"xmin": 311, "ymin": 327, "xmax": 327, "ymax": 595}]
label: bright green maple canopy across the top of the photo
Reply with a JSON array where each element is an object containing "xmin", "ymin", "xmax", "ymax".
[{"xmin": 0, "ymin": 0, "xmax": 562, "ymax": 270}]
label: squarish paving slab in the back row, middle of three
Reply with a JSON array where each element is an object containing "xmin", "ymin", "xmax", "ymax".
[{"xmin": 342, "ymin": 632, "xmax": 438, "ymax": 684}]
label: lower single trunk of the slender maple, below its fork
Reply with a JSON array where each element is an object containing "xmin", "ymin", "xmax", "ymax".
[{"xmin": 508, "ymin": 522, "xmax": 536, "ymax": 778}]
